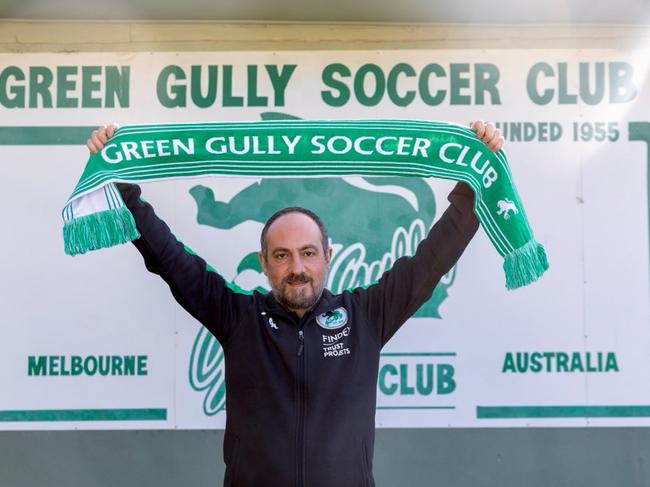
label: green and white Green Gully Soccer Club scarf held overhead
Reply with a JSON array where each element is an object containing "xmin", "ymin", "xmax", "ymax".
[{"xmin": 63, "ymin": 120, "xmax": 548, "ymax": 289}]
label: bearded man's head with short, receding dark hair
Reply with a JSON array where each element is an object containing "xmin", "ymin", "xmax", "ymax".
[{"xmin": 259, "ymin": 213, "xmax": 332, "ymax": 317}]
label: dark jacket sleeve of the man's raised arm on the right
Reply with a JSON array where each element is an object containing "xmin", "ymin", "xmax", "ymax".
[{"xmin": 357, "ymin": 183, "xmax": 478, "ymax": 347}]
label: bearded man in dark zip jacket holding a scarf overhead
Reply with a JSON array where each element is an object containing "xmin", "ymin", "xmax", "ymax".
[{"xmin": 87, "ymin": 121, "xmax": 503, "ymax": 487}]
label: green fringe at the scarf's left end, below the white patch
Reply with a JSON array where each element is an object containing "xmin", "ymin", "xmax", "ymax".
[{"xmin": 63, "ymin": 206, "xmax": 140, "ymax": 255}]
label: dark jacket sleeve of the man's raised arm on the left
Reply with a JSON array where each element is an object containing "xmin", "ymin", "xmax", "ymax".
[{"xmin": 117, "ymin": 183, "xmax": 249, "ymax": 345}]
